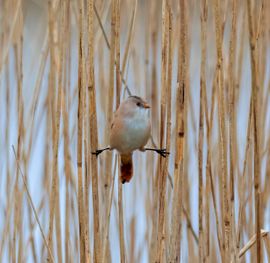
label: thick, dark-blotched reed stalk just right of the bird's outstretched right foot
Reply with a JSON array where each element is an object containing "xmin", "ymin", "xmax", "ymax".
[{"xmin": 170, "ymin": 0, "xmax": 188, "ymax": 262}]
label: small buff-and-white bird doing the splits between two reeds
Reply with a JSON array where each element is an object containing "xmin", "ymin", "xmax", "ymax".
[{"xmin": 92, "ymin": 96, "xmax": 169, "ymax": 184}]
